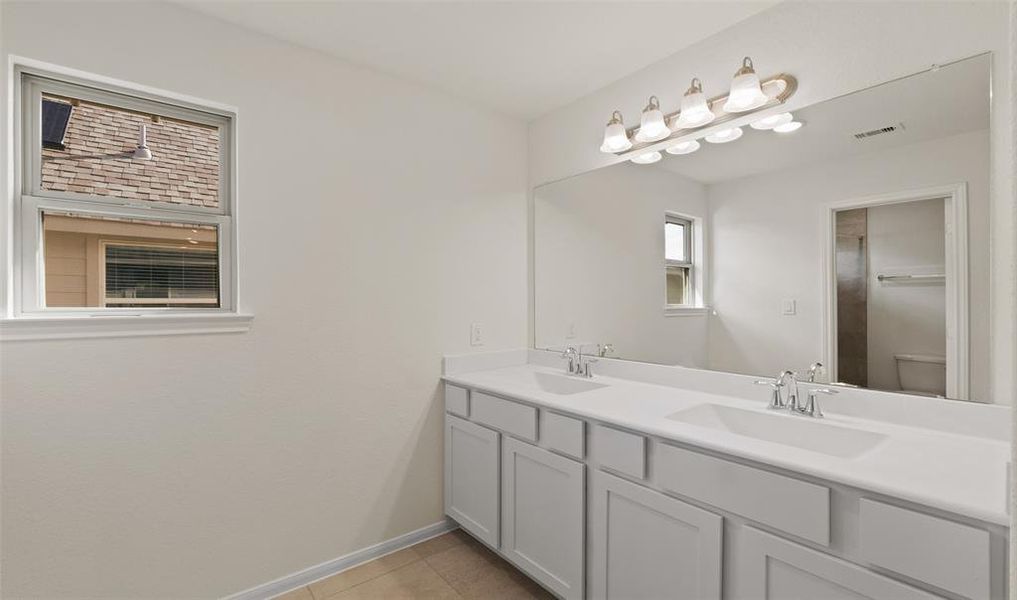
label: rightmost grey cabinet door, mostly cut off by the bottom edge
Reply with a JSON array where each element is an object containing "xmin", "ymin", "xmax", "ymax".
[{"xmin": 735, "ymin": 527, "xmax": 939, "ymax": 600}]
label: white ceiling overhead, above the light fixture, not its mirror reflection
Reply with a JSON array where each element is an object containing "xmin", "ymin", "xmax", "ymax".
[{"xmin": 177, "ymin": 0, "xmax": 777, "ymax": 119}]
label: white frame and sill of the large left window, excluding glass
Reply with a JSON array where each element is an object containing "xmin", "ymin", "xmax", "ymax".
[{"xmin": 0, "ymin": 57, "xmax": 252, "ymax": 341}]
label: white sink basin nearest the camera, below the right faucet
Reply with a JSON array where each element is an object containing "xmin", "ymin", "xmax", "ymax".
[{"xmin": 667, "ymin": 404, "xmax": 886, "ymax": 459}]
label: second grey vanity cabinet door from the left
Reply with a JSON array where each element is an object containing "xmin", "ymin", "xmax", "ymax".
[{"xmin": 501, "ymin": 437, "xmax": 586, "ymax": 598}]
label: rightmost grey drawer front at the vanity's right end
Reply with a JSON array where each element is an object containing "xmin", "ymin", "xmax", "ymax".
[{"xmin": 858, "ymin": 498, "xmax": 991, "ymax": 598}]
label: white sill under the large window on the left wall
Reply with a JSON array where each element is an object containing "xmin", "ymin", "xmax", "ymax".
[{"xmin": 0, "ymin": 313, "xmax": 254, "ymax": 342}]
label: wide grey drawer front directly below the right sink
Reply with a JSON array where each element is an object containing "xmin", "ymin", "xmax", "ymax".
[{"xmin": 655, "ymin": 443, "xmax": 830, "ymax": 546}]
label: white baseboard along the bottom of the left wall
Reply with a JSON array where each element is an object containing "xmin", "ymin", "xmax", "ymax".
[{"xmin": 224, "ymin": 519, "xmax": 459, "ymax": 600}]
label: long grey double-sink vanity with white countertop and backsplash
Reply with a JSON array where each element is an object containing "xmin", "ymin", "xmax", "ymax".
[{"xmin": 444, "ymin": 350, "xmax": 1010, "ymax": 600}]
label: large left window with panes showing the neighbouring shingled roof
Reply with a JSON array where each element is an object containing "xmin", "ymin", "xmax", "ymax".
[{"xmin": 11, "ymin": 68, "xmax": 236, "ymax": 316}]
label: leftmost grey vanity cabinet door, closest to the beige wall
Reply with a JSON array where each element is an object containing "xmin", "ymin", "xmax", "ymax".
[{"xmin": 444, "ymin": 415, "xmax": 500, "ymax": 548}]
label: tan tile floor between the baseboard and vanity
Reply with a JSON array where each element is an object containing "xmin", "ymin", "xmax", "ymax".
[{"xmin": 275, "ymin": 530, "xmax": 553, "ymax": 600}]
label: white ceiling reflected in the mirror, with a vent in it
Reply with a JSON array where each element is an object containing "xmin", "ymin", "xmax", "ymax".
[{"xmin": 654, "ymin": 55, "xmax": 990, "ymax": 184}]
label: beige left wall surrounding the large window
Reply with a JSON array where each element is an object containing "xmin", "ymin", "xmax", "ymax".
[{"xmin": 0, "ymin": 2, "xmax": 527, "ymax": 598}]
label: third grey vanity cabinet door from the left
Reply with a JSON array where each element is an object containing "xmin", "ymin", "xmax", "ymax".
[{"xmin": 590, "ymin": 472, "xmax": 724, "ymax": 600}]
